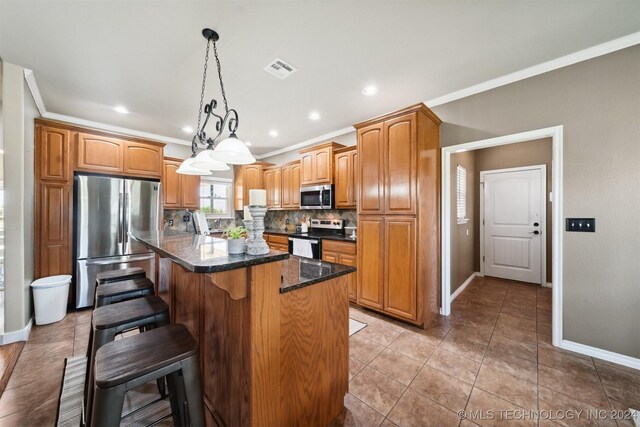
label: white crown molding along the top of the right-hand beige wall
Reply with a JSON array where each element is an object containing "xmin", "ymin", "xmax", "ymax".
[{"xmin": 424, "ymin": 32, "xmax": 640, "ymax": 108}]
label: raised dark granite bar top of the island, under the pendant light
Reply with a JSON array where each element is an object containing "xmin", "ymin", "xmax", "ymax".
[{"xmin": 131, "ymin": 231, "xmax": 289, "ymax": 273}]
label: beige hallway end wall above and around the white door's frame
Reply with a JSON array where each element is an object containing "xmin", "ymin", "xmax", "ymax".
[{"xmin": 473, "ymin": 138, "xmax": 552, "ymax": 282}]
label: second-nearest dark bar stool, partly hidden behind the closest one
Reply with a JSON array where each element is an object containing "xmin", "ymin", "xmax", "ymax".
[{"xmin": 85, "ymin": 296, "xmax": 169, "ymax": 423}]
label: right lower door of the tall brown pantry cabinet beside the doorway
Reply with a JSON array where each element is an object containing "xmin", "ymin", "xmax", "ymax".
[{"xmin": 382, "ymin": 217, "xmax": 418, "ymax": 322}]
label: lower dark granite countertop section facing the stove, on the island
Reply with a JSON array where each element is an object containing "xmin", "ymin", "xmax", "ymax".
[{"xmin": 280, "ymin": 255, "xmax": 356, "ymax": 294}]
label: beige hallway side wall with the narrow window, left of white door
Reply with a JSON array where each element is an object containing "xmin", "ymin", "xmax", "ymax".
[{"xmin": 450, "ymin": 151, "xmax": 480, "ymax": 294}]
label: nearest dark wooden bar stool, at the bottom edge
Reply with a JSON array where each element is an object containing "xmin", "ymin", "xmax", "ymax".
[{"xmin": 90, "ymin": 324, "xmax": 205, "ymax": 426}]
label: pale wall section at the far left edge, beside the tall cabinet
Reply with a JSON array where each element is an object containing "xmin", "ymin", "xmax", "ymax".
[{"xmin": 2, "ymin": 62, "xmax": 38, "ymax": 333}]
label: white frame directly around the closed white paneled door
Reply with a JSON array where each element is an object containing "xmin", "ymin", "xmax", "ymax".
[{"xmin": 478, "ymin": 165, "xmax": 548, "ymax": 285}]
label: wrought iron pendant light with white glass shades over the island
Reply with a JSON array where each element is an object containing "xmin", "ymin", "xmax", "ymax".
[{"xmin": 177, "ymin": 28, "xmax": 256, "ymax": 175}]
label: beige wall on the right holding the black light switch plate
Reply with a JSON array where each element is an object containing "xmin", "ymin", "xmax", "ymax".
[{"xmin": 433, "ymin": 46, "xmax": 640, "ymax": 358}]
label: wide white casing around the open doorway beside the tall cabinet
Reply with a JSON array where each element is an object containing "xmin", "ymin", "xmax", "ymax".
[{"xmin": 441, "ymin": 125, "xmax": 564, "ymax": 346}]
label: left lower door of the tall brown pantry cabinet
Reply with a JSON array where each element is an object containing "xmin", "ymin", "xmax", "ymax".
[{"xmin": 357, "ymin": 215, "xmax": 384, "ymax": 309}]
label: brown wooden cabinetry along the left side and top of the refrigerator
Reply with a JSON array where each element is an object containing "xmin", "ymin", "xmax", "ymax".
[{"xmin": 34, "ymin": 119, "xmax": 164, "ymax": 290}]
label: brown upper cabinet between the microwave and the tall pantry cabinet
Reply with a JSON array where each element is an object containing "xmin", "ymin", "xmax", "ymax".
[{"xmin": 333, "ymin": 147, "xmax": 358, "ymax": 209}]
